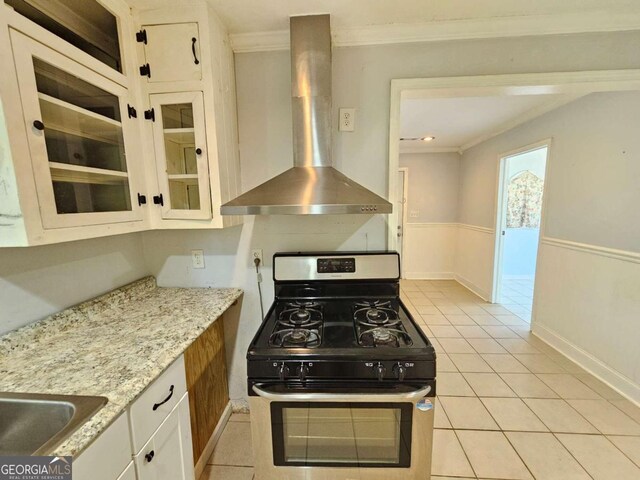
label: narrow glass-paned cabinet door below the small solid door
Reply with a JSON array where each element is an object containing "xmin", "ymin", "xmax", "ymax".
[{"xmin": 149, "ymin": 92, "xmax": 211, "ymax": 219}]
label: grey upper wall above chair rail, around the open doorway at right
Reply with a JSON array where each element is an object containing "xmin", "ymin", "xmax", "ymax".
[{"xmin": 460, "ymin": 92, "xmax": 640, "ymax": 251}]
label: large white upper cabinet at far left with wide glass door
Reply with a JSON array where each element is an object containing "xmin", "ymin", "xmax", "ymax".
[{"xmin": 0, "ymin": 0, "xmax": 150, "ymax": 247}]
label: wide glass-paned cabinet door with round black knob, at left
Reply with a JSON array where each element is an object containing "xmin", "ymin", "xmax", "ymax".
[{"xmin": 11, "ymin": 31, "xmax": 142, "ymax": 228}]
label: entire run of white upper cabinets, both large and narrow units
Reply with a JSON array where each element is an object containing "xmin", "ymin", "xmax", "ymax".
[{"xmin": 0, "ymin": 0, "xmax": 242, "ymax": 247}]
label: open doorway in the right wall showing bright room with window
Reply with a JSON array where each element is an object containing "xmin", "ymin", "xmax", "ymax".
[{"xmin": 494, "ymin": 142, "xmax": 549, "ymax": 322}]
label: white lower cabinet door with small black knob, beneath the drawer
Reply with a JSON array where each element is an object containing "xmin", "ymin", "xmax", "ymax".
[{"xmin": 134, "ymin": 393, "xmax": 195, "ymax": 480}]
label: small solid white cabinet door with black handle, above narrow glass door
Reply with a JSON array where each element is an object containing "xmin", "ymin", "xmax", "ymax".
[{"xmin": 138, "ymin": 22, "xmax": 202, "ymax": 83}]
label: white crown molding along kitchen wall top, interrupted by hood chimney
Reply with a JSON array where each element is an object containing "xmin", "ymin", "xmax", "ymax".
[{"xmin": 230, "ymin": 12, "xmax": 640, "ymax": 53}]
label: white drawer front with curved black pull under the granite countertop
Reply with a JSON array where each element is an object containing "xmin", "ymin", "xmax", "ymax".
[{"xmin": 129, "ymin": 356, "xmax": 187, "ymax": 454}]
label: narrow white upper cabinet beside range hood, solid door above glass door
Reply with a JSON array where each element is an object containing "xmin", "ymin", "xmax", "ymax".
[{"xmin": 135, "ymin": 1, "xmax": 242, "ymax": 229}]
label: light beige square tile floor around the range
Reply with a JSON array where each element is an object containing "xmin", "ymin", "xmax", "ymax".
[{"xmin": 200, "ymin": 280, "xmax": 640, "ymax": 480}]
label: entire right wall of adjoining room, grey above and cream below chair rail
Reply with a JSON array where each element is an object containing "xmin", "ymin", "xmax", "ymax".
[{"xmin": 457, "ymin": 92, "xmax": 640, "ymax": 401}]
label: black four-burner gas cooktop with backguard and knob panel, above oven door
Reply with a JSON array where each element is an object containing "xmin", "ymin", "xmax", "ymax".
[{"xmin": 247, "ymin": 252, "xmax": 436, "ymax": 395}]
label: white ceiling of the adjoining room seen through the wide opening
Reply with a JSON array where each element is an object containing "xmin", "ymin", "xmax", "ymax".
[{"xmin": 400, "ymin": 94, "xmax": 575, "ymax": 152}]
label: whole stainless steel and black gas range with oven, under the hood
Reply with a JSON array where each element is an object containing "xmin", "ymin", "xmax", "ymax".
[{"xmin": 247, "ymin": 252, "xmax": 436, "ymax": 480}]
